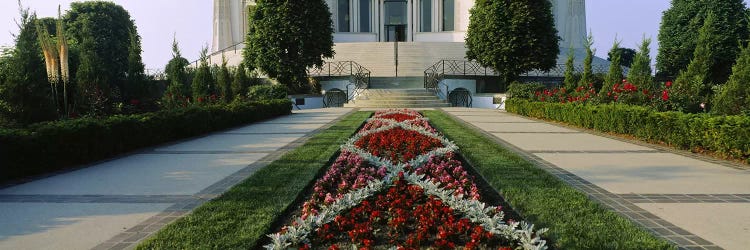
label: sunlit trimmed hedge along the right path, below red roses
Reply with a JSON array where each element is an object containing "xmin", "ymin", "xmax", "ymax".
[{"xmin": 506, "ymin": 99, "xmax": 750, "ymax": 163}]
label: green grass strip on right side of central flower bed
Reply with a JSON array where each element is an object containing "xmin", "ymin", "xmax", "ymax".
[{"xmin": 423, "ymin": 111, "xmax": 675, "ymax": 249}]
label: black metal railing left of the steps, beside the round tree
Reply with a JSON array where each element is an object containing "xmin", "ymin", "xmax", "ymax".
[{"xmin": 307, "ymin": 61, "xmax": 372, "ymax": 107}]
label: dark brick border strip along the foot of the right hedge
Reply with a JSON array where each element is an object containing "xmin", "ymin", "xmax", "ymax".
[{"xmin": 494, "ymin": 112, "xmax": 750, "ymax": 171}]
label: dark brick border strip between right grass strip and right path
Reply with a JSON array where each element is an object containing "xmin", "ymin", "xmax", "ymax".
[{"xmin": 439, "ymin": 108, "xmax": 718, "ymax": 249}]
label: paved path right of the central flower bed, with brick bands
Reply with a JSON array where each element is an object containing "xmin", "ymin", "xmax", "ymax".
[{"xmin": 443, "ymin": 108, "xmax": 750, "ymax": 249}]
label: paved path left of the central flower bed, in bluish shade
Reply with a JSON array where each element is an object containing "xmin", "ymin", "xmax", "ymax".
[{"xmin": 0, "ymin": 109, "xmax": 352, "ymax": 249}]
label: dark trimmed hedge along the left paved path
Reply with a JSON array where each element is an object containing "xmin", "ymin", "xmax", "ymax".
[{"xmin": 0, "ymin": 100, "xmax": 292, "ymax": 182}]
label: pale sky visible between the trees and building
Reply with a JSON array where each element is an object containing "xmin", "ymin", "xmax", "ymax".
[{"xmin": 0, "ymin": 0, "xmax": 750, "ymax": 69}]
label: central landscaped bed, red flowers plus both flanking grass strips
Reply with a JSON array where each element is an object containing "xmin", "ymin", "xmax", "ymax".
[{"xmin": 138, "ymin": 108, "xmax": 674, "ymax": 249}]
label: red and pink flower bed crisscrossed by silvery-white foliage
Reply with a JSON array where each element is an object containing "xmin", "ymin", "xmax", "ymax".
[{"xmin": 266, "ymin": 110, "xmax": 546, "ymax": 249}]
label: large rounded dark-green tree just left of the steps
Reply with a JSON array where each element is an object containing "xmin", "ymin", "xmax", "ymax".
[{"xmin": 244, "ymin": 0, "xmax": 333, "ymax": 93}]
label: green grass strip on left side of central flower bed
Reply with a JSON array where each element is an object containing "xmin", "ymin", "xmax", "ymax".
[{"xmin": 137, "ymin": 112, "xmax": 371, "ymax": 249}]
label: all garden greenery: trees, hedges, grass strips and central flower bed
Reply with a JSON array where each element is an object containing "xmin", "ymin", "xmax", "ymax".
[{"xmin": 0, "ymin": 0, "xmax": 750, "ymax": 249}]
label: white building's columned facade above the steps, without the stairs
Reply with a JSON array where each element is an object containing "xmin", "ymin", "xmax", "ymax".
[{"xmin": 212, "ymin": 0, "xmax": 586, "ymax": 51}]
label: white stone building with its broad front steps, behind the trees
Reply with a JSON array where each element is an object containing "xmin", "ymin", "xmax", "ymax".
[{"xmin": 211, "ymin": 0, "xmax": 609, "ymax": 108}]
